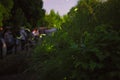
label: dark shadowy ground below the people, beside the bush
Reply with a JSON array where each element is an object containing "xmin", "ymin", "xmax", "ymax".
[{"xmin": 0, "ymin": 52, "xmax": 36, "ymax": 80}]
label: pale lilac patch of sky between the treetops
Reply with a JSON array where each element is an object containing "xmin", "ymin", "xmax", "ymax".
[{"xmin": 43, "ymin": 0, "xmax": 78, "ymax": 15}]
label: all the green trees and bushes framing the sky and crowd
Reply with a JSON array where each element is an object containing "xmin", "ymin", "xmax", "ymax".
[{"xmin": 0, "ymin": 0, "xmax": 120, "ymax": 80}]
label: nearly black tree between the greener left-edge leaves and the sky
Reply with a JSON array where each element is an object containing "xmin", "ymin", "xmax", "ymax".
[{"xmin": 9, "ymin": 0, "xmax": 45, "ymax": 27}]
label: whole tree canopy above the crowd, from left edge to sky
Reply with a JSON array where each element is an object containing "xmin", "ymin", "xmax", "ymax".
[{"xmin": 0, "ymin": 0, "xmax": 45, "ymax": 29}]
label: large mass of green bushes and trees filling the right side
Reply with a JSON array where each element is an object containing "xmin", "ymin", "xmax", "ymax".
[{"xmin": 31, "ymin": 0, "xmax": 120, "ymax": 80}]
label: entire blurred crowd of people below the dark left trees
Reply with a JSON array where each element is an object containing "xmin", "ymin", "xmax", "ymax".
[{"xmin": 0, "ymin": 26, "xmax": 56, "ymax": 58}]
